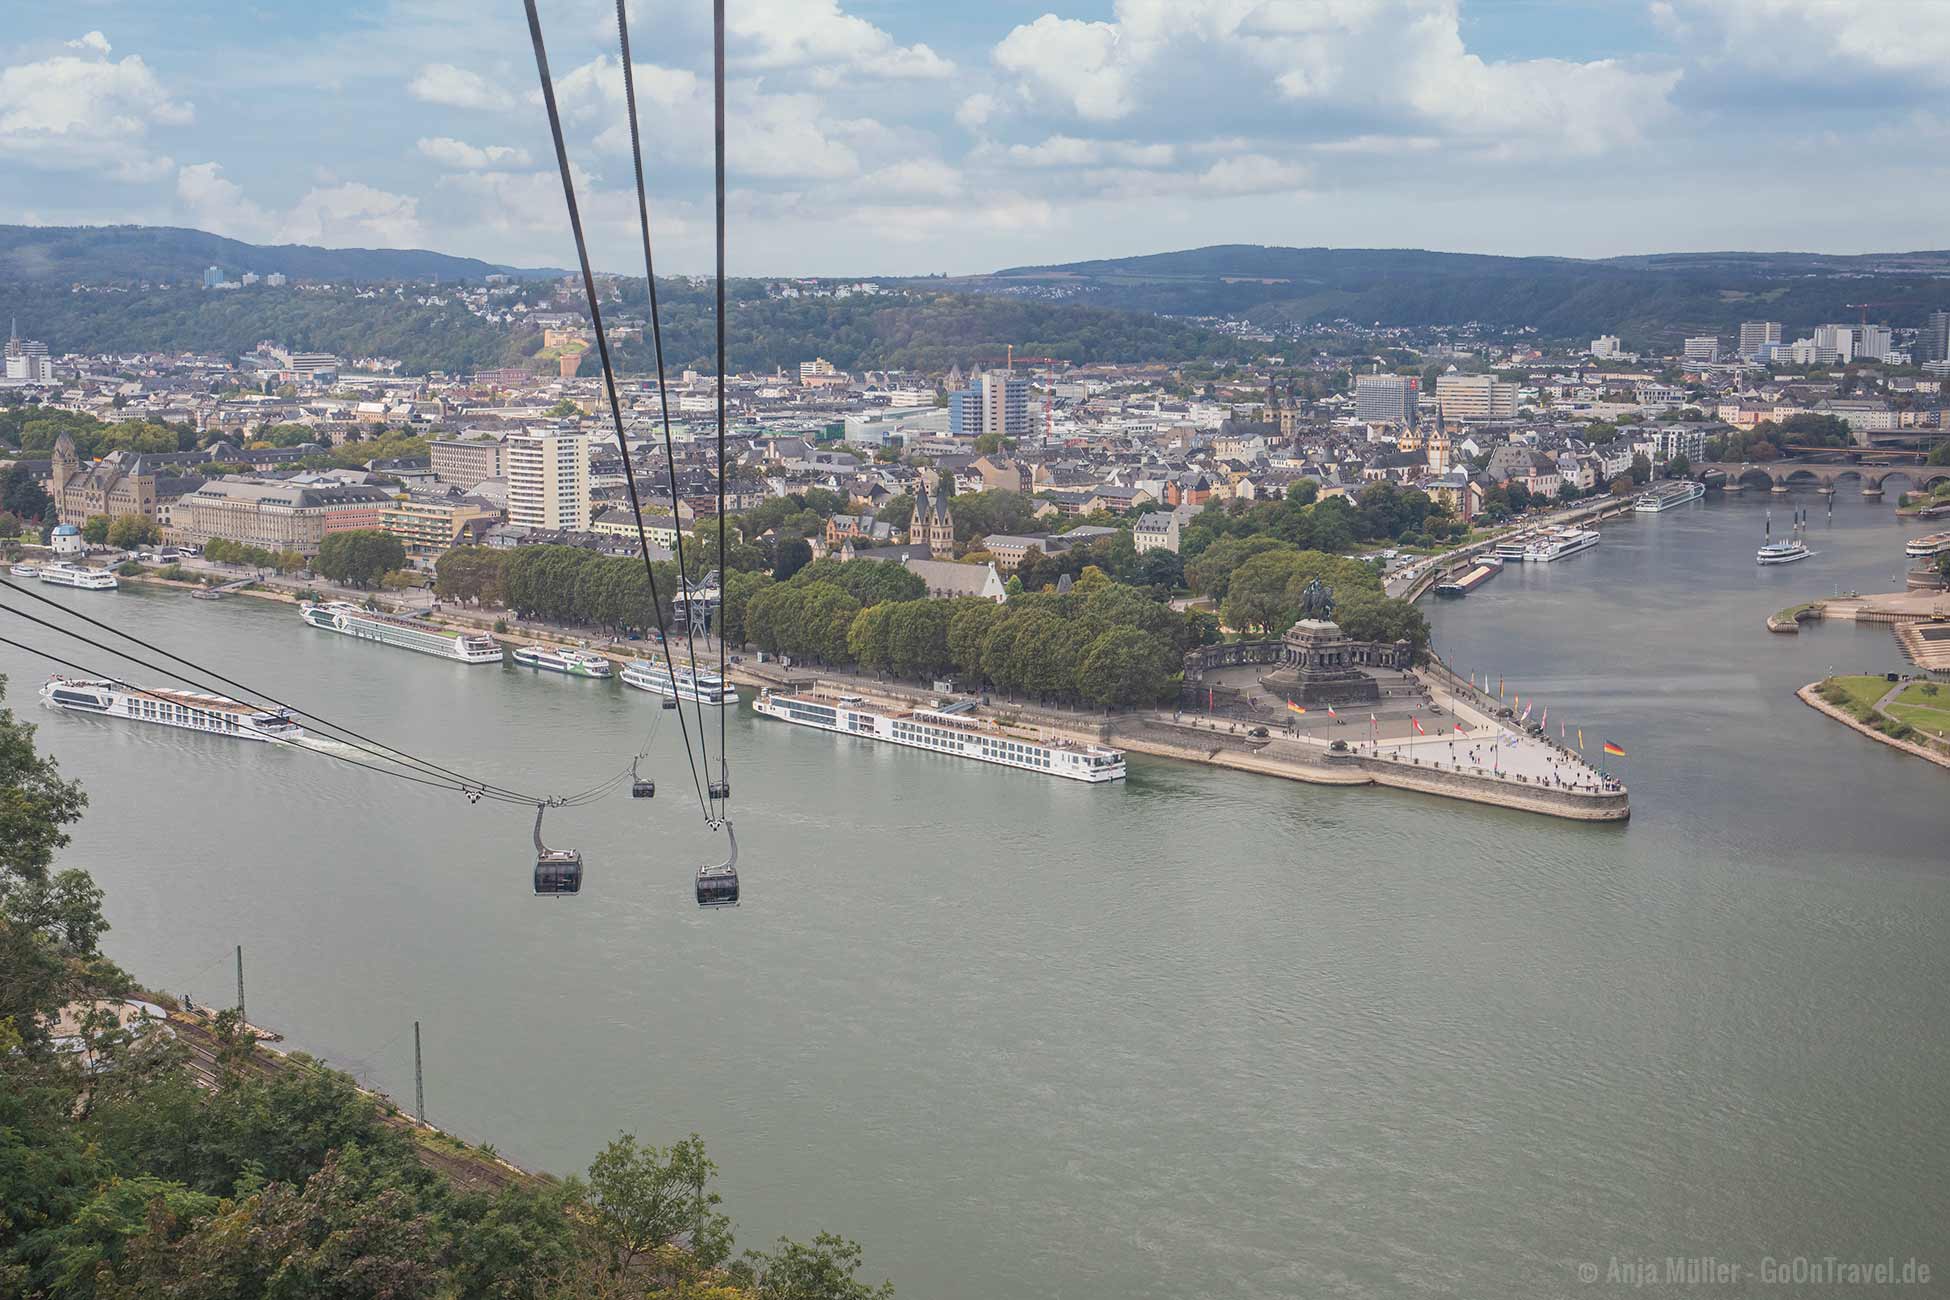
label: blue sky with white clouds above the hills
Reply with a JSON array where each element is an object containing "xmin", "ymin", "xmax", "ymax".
[{"xmin": 0, "ymin": 0, "xmax": 1950, "ymax": 275}]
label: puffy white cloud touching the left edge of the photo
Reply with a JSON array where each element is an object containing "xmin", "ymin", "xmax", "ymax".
[{"xmin": 0, "ymin": 45, "xmax": 195, "ymax": 181}]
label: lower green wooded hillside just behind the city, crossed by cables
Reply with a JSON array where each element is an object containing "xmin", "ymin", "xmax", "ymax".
[{"xmin": 0, "ymin": 281, "xmax": 1252, "ymax": 374}]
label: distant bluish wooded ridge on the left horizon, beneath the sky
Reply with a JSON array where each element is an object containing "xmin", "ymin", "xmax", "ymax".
[{"xmin": 0, "ymin": 226, "xmax": 558, "ymax": 285}]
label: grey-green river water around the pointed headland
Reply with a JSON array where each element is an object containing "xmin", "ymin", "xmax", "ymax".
[{"xmin": 0, "ymin": 495, "xmax": 1950, "ymax": 1300}]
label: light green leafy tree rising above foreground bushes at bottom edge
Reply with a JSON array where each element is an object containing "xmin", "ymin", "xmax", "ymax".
[{"xmin": 587, "ymin": 1132, "xmax": 731, "ymax": 1277}]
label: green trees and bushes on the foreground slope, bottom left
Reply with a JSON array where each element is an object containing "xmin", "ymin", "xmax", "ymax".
[{"xmin": 0, "ymin": 678, "xmax": 893, "ymax": 1300}]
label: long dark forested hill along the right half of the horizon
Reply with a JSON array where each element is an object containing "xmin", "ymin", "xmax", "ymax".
[{"xmin": 951, "ymin": 244, "xmax": 1950, "ymax": 345}]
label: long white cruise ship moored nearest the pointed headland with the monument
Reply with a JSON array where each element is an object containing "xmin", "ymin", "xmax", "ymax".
[{"xmin": 753, "ymin": 690, "xmax": 1125, "ymax": 782}]
